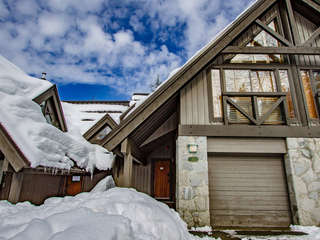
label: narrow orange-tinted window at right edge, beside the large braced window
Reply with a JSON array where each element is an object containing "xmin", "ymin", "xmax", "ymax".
[{"xmin": 300, "ymin": 70, "xmax": 320, "ymax": 119}]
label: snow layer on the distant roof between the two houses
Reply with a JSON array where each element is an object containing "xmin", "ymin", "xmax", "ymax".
[{"xmin": 62, "ymin": 101, "xmax": 128, "ymax": 134}]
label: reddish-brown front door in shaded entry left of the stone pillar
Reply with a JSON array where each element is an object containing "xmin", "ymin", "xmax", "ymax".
[{"xmin": 154, "ymin": 160, "xmax": 170, "ymax": 199}]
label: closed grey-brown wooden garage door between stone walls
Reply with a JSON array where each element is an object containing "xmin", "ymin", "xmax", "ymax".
[{"xmin": 208, "ymin": 155, "xmax": 291, "ymax": 227}]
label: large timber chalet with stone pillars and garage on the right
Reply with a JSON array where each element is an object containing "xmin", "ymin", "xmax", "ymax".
[{"xmin": 100, "ymin": 0, "xmax": 320, "ymax": 227}]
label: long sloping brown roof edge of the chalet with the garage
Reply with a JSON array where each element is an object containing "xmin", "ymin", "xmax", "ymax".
[{"xmin": 103, "ymin": 0, "xmax": 277, "ymax": 150}]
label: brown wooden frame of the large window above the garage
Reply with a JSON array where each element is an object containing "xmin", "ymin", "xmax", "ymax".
[{"xmin": 207, "ymin": 63, "xmax": 300, "ymax": 125}]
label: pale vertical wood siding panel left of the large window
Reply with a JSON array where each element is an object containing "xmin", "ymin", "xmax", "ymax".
[{"xmin": 180, "ymin": 71, "xmax": 210, "ymax": 125}]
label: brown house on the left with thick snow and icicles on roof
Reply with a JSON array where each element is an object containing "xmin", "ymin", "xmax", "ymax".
[{"xmin": 0, "ymin": 56, "xmax": 113, "ymax": 204}]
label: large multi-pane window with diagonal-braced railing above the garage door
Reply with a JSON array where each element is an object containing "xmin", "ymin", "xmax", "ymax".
[{"xmin": 211, "ymin": 68, "xmax": 295, "ymax": 125}]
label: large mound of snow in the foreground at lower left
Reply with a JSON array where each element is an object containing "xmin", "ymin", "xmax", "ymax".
[{"xmin": 0, "ymin": 188, "xmax": 198, "ymax": 240}]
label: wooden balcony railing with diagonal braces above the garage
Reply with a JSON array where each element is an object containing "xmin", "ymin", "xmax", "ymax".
[{"xmin": 222, "ymin": 92, "xmax": 289, "ymax": 125}]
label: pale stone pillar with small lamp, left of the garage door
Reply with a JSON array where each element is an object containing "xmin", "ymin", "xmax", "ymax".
[{"xmin": 176, "ymin": 136, "xmax": 210, "ymax": 227}]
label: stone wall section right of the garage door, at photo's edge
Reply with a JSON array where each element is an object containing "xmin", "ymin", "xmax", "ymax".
[{"xmin": 285, "ymin": 138, "xmax": 320, "ymax": 225}]
